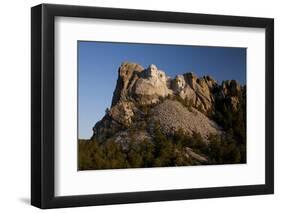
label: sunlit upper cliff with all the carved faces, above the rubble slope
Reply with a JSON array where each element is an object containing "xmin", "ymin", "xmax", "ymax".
[{"xmin": 109, "ymin": 62, "xmax": 221, "ymax": 112}]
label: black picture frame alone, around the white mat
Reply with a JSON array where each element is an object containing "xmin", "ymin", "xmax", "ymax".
[{"xmin": 31, "ymin": 4, "xmax": 274, "ymax": 209}]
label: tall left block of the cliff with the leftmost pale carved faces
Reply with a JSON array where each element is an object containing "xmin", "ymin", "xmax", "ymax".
[{"xmin": 111, "ymin": 62, "xmax": 173, "ymax": 107}]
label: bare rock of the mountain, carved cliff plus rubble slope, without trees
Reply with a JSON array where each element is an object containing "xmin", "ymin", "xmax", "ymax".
[{"xmin": 93, "ymin": 62, "xmax": 241, "ymax": 140}]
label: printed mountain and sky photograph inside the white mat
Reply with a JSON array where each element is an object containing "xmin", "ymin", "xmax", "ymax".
[{"xmin": 77, "ymin": 41, "xmax": 247, "ymax": 170}]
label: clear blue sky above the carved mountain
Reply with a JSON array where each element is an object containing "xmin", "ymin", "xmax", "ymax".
[{"xmin": 78, "ymin": 41, "xmax": 246, "ymax": 139}]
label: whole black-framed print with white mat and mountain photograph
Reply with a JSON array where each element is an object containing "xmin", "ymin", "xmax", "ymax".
[{"xmin": 31, "ymin": 4, "xmax": 274, "ymax": 208}]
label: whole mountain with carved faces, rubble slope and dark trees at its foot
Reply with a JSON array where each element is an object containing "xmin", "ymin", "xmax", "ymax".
[{"xmin": 78, "ymin": 62, "xmax": 247, "ymax": 170}]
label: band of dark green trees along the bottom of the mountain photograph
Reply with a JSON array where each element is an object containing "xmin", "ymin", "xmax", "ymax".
[{"xmin": 78, "ymin": 123, "xmax": 243, "ymax": 170}]
